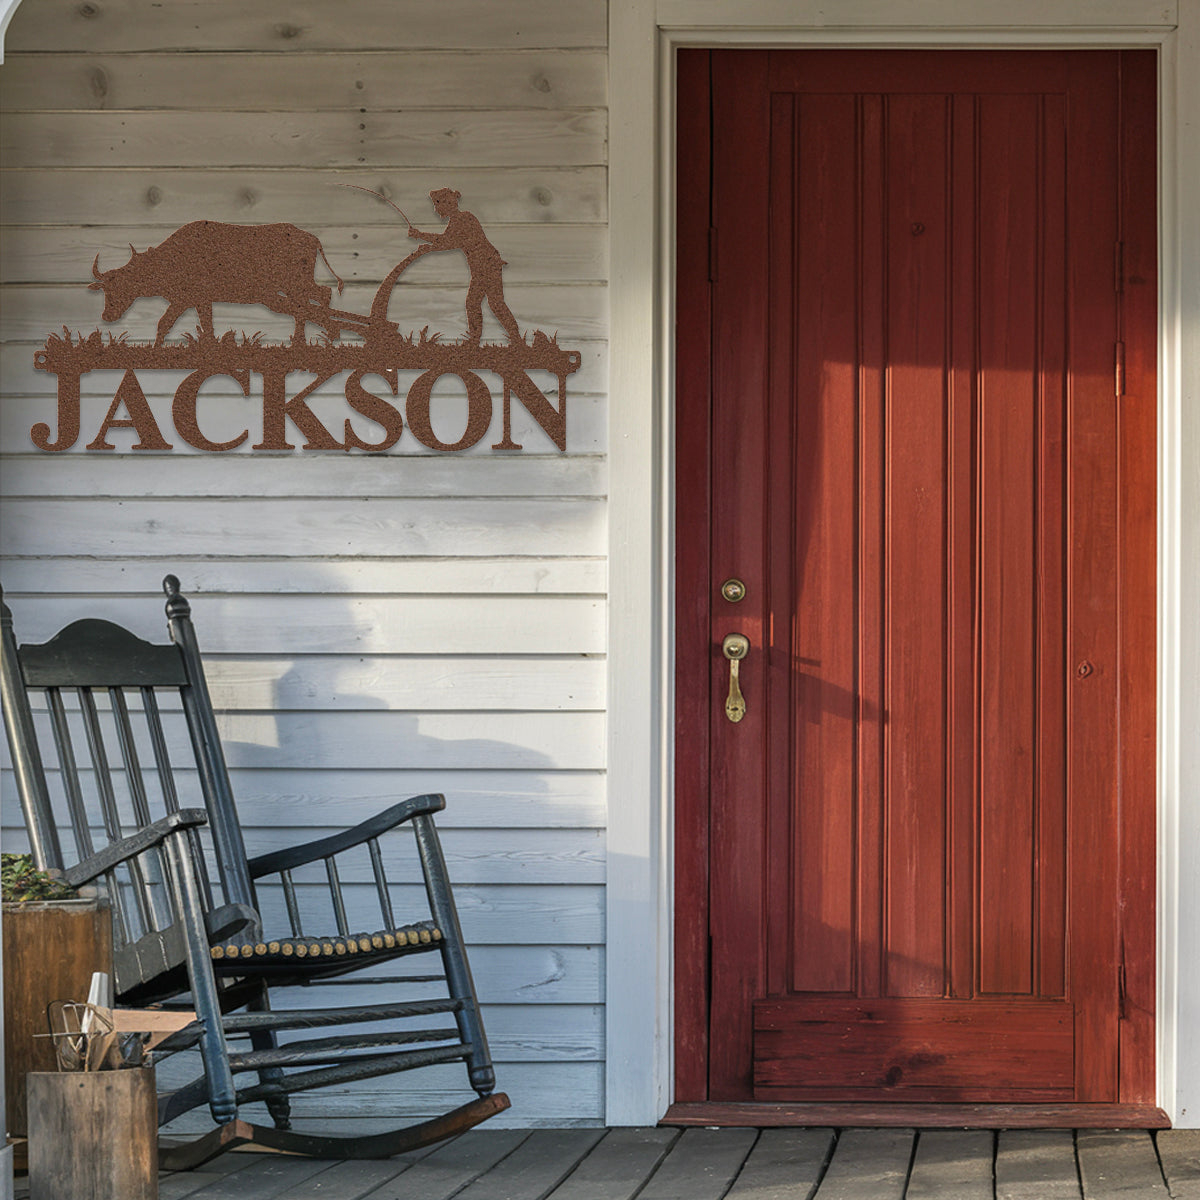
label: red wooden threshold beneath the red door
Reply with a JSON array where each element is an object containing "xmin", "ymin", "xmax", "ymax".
[{"xmin": 659, "ymin": 1100, "xmax": 1171, "ymax": 1129}]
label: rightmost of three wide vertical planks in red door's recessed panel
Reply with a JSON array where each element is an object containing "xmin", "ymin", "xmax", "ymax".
[{"xmin": 977, "ymin": 96, "xmax": 1057, "ymax": 995}]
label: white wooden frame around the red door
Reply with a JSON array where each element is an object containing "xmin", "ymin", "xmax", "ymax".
[{"xmin": 606, "ymin": 0, "xmax": 1200, "ymax": 1127}]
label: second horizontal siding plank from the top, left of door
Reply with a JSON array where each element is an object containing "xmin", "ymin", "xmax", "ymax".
[{"xmin": 0, "ymin": 51, "xmax": 607, "ymax": 113}]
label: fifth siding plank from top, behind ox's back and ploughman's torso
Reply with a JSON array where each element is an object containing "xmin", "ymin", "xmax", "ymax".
[{"xmin": 0, "ymin": 223, "xmax": 608, "ymax": 285}]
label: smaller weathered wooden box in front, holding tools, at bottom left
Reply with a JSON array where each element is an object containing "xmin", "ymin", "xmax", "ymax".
[{"xmin": 26, "ymin": 1067, "xmax": 158, "ymax": 1200}]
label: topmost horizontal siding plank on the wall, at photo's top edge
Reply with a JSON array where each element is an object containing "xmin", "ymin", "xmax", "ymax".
[{"xmin": 6, "ymin": 0, "xmax": 607, "ymax": 53}]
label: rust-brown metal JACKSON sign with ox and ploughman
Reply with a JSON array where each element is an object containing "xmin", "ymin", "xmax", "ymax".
[{"xmin": 30, "ymin": 187, "xmax": 580, "ymax": 452}]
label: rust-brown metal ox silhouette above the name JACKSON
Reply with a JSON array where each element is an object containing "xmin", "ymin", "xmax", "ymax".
[{"xmin": 88, "ymin": 221, "xmax": 344, "ymax": 347}]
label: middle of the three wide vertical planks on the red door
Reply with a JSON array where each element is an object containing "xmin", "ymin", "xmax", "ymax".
[{"xmin": 883, "ymin": 95, "xmax": 949, "ymax": 996}]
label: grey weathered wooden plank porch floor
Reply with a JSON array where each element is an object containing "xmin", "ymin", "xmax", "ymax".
[{"xmin": 142, "ymin": 1128, "xmax": 1200, "ymax": 1200}]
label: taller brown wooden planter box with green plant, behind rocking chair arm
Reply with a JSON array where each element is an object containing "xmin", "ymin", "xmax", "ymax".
[{"xmin": 4, "ymin": 900, "xmax": 113, "ymax": 1138}]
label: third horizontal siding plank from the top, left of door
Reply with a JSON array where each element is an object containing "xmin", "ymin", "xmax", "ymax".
[{"xmin": 0, "ymin": 108, "xmax": 606, "ymax": 169}]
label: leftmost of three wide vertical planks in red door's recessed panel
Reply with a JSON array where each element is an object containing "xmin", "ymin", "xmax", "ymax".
[{"xmin": 787, "ymin": 96, "xmax": 858, "ymax": 992}]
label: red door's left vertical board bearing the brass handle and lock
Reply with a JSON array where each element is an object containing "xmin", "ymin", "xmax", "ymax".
[{"xmin": 708, "ymin": 50, "xmax": 775, "ymax": 1099}]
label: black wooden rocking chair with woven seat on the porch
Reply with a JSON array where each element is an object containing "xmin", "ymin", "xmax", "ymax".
[{"xmin": 0, "ymin": 575, "xmax": 509, "ymax": 1168}]
